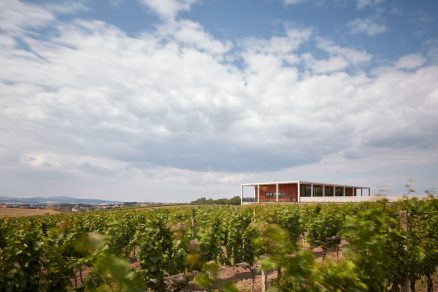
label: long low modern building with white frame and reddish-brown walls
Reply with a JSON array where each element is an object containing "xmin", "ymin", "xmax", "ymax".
[{"xmin": 240, "ymin": 181, "xmax": 371, "ymax": 205}]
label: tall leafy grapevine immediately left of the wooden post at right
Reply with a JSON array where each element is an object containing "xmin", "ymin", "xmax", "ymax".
[{"xmin": 343, "ymin": 208, "xmax": 407, "ymax": 291}]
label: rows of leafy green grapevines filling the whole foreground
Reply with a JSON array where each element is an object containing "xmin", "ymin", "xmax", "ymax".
[{"xmin": 0, "ymin": 197, "xmax": 438, "ymax": 291}]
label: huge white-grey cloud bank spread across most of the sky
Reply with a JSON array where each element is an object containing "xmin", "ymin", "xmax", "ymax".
[{"xmin": 0, "ymin": 0, "xmax": 438, "ymax": 201}]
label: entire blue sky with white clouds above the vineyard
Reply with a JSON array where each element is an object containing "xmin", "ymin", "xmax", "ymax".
[{"xmin": 0, "ymin": 0, "xmax": 438, "ymax": 202}]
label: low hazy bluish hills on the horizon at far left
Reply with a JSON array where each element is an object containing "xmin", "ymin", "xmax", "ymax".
[{"xmin": 0, "ymin": 196, "xmax": 123, "ymax": 205}]
